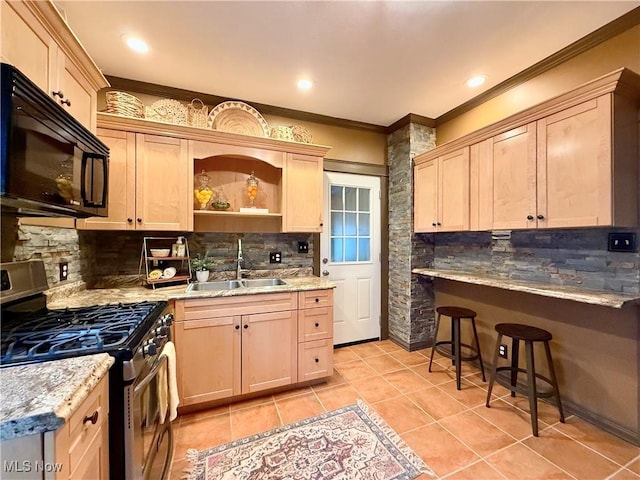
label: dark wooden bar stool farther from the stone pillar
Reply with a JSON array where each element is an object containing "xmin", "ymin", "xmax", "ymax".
[{"xmin": 487, "ymin": 323, "xmax": 564, "ymax": 437}]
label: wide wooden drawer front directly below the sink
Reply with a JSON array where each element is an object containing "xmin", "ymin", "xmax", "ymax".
[{"xmin": 176, "ymin": 292, "xmax": 298, "ymax": 321}]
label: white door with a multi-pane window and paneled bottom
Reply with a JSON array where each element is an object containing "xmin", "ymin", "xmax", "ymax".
[{"xmin": 320, "ymin": 172, "xmax": 380, "ymax": 345}]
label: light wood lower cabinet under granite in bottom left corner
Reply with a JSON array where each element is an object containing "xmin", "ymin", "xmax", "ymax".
[{"xmin": 0, "ymin": 375, "xmax": 109, "ymax": 480}]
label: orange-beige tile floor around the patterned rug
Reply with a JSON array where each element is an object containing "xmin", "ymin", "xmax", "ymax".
[{"xmin": 171, "ymin": 340, "xmax": 640, "ymax": 480}]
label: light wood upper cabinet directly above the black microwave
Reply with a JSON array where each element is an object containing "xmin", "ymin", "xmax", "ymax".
[{"xmin": 0, "ymin": 1, "xmax": 109, "ymax": 132}]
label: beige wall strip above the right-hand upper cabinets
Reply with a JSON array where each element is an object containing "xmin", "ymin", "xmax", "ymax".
[{"xmin": 436, "ymin": 25, "xmax": 640, "ymax": 145}]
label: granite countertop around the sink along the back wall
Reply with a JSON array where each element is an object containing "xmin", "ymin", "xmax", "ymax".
[{"xmin": 47, "ymin": 277, "xmax": 336, "ymax": 309}]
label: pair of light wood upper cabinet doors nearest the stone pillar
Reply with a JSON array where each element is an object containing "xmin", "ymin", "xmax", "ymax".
[{"xmin": 413, "ymin": 147, "xmax": 469, "ymax": 232}]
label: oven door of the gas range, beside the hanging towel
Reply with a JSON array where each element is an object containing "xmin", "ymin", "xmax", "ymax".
[{"xmin": 127, "ymin": 356, "xmax": 173, "ymax": 480}]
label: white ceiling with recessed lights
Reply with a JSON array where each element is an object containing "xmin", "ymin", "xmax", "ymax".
[{"xmin": 56, "ymin": 0, "xmax": 640, "ymax": 126}]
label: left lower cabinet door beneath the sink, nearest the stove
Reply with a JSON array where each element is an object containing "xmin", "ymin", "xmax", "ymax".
[{"xmin": 174, "ymin": 316, "xmax": 241, "ymax": 406}]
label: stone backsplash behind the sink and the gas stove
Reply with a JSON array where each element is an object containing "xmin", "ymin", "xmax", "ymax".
[{"xmin": 2, "ymin": 217, "xmax": 314, "ymax": 288}]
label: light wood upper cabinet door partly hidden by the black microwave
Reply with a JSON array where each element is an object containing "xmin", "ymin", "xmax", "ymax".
[{"xmin": 76, "ymin": 129, "xmax": 136, "ymax": 230}]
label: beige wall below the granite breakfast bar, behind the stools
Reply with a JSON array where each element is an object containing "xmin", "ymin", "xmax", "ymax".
[{"xmin": 435, "ymin": 279, "xmax": 640, "ymax": 442}]
